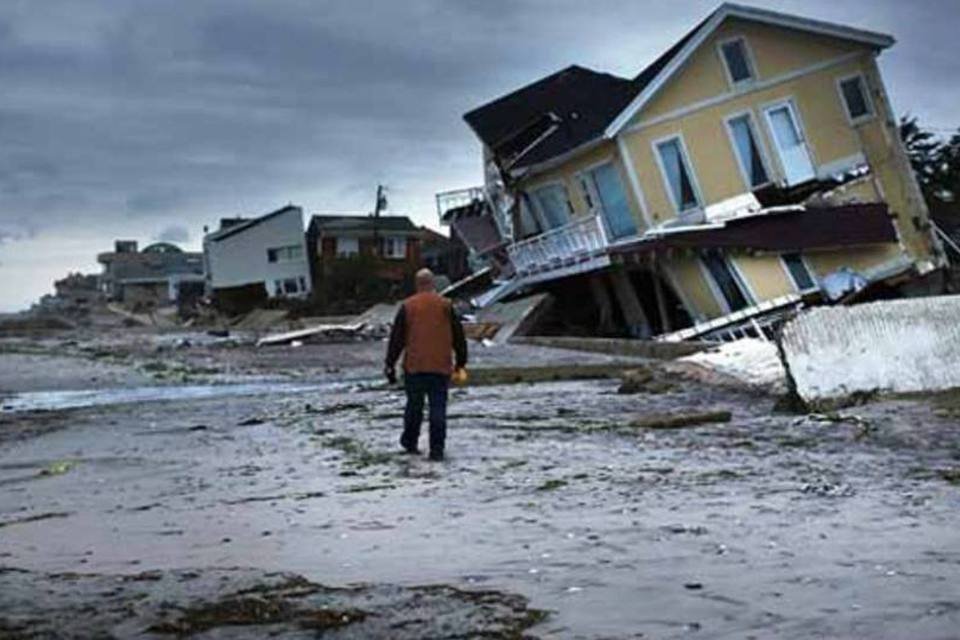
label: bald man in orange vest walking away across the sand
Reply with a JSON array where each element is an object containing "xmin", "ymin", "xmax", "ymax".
[{"xmin": 384, "ymin": 269, "xmax": 467, "ymax": 460}]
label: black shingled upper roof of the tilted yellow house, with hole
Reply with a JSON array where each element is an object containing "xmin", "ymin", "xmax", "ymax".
[{"xmin": 463, "ymin": 13, "xmax": 713, "ymax": 168}]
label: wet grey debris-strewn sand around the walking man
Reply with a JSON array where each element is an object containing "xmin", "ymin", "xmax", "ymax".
[{"xmin": 0, "ymin": 338, "xmax": 960, "ymax": 638}]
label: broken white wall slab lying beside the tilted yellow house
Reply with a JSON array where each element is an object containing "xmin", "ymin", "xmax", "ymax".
[{"xmin": 782, "ymin": 296, "xmax": 960, "ymax": 402}]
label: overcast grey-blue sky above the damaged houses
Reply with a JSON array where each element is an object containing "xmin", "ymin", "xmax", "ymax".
[{"xmin": 0, "ymin": 0, "xmax": 960, "ymax": 310}]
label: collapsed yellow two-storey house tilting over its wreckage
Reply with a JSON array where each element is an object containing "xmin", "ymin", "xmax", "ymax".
[{"xmin": 438, "ymin": 4, "xmax": 945, "ymax": 339}]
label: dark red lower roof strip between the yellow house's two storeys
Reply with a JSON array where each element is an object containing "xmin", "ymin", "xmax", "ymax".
[{"xmin": 611, "ymin": 203, "xmax": 897, "ymax": 254}]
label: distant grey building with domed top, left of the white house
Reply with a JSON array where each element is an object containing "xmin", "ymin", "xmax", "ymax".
[{"xmin": 97, "ymin": 240, "xmax": 204, "ymax": 306}]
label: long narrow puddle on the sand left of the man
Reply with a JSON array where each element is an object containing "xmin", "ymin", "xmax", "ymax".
[{"xmin": 2, "ymin": 378, "xmax": 376, "ymax": 413}]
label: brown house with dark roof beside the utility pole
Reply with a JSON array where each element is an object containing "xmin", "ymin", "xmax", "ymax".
[{"xmin": 307, "ymin": 214, "xmax": 421, "ymax": 282}]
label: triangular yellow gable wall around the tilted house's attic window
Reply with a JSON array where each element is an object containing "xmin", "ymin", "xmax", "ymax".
[{"xmin": 630, "ymin": 18, "xmax": 873, "ymax": 124}]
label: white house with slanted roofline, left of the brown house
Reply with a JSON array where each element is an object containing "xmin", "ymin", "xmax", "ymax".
[{"xmin": 203, "ymin": 205, "xmax": 313, "ymax": 298}]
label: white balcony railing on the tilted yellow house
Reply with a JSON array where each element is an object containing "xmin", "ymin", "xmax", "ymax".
[{"xmin": 507, "ymin": 216, "xmax": 609, "ymax": 276}]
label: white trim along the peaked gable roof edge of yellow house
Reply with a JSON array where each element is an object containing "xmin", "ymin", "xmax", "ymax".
[{"xmin": 604, "ymin": 3, "xmax": 895, "ymax": 138}]
